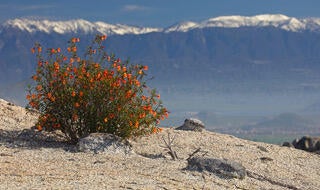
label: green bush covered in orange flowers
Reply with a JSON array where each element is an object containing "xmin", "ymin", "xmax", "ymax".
[{"xmin": 27, "ymin": 35, "xmax": 168, "ymax": 142}]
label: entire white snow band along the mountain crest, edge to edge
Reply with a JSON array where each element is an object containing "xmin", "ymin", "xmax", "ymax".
[{"xmin": 0, "ymin": 14, "xmax": 320, "ymax": 35}]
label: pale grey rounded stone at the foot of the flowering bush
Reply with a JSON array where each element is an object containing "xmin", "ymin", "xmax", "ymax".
[{"xmin": 77, "ymin": 133, "xmax": 133, "ymax": 154}]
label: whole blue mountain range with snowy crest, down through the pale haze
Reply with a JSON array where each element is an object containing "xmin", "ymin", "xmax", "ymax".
[{"xmin": 0, "ymin": 15, "xmax": 320, "ymax": 117}]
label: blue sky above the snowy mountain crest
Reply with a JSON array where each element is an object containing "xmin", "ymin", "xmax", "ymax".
[{"xmin": 0, "ymin": 0, "xmax": 320, "ymax": 27}]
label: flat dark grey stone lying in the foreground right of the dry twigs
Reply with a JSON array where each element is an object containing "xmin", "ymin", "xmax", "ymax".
[{"xmin": 187, "ymin": 157, "xmax": 247, "ymax": 179}]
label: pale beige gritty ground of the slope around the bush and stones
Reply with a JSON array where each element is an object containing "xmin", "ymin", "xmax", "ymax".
[{"xmin": 0, "ymin": 100, "xmax": 320, "ymax": 190}]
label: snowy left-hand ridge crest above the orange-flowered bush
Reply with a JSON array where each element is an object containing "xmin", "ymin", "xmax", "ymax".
[{"xmin": 3, "ymin": 19, "xmax": 160, "ymax": 35}]
